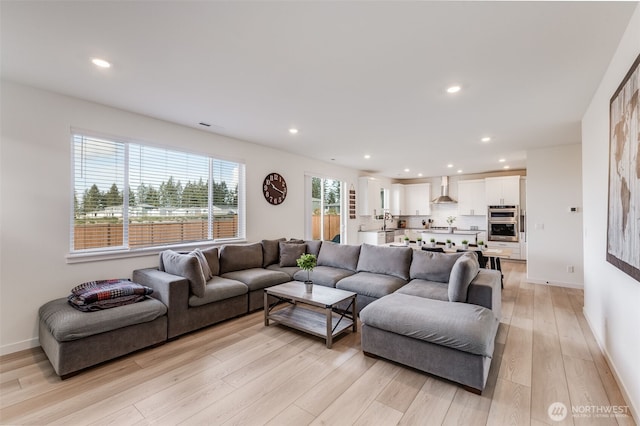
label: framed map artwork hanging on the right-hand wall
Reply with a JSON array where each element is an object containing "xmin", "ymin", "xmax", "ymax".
[{"xmin": 607, "ymin": 51, "xmax": 640, "ymax": 281}]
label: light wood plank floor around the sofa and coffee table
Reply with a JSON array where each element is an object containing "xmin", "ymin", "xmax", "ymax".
[{"xmin": 0, "ymin": 262, "xmax": 634, "ymax": 425}]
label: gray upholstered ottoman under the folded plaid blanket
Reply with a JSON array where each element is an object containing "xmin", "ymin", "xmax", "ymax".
[{"xmin": 38, "ymin": 297, "xmax": 167, "ymax": 379}]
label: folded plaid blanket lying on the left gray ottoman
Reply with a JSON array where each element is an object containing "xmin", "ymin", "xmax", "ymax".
[{"xmin": 67, "ymin": 279, "xmax": 153, "ymax": 312}]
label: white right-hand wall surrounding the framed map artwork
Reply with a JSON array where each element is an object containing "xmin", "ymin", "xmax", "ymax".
[{"xmin": 582, "ymin": 1, "xmax": 640, "ymax": 420}]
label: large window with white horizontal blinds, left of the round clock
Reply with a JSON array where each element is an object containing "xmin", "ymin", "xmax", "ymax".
[{"xmin": 71, "ymin": 134, "xmax": 245, "ymax": 253}]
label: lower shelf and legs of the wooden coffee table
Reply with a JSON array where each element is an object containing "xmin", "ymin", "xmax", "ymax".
[{"xmin": 267, "ymin": 305, "xmax": 353, "ymax": 348}]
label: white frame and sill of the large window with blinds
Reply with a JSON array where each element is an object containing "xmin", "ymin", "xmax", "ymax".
[{"xmin": 66, "ymin": 128, "xmax": 247, "ymax": 263}]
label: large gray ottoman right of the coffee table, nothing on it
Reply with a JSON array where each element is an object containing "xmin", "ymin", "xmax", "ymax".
[{"xmin": 360, "ymin": 293, "xmax": 499, "ymax": 393}]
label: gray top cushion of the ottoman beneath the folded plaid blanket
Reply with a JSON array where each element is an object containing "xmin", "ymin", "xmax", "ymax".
[{"xmin": 38, "ymin": 297, "xmax": 167, "ymax": 342}]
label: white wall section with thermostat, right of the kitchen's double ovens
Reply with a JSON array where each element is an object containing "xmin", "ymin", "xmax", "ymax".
[{"xmin": 526, "ymin": 144, "xmax": 584, "ymax": 287}]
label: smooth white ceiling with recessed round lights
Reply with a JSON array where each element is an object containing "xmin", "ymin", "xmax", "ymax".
[{"xmin": 1, "ymin": 0, "xmax": 638, "ymax": 178}]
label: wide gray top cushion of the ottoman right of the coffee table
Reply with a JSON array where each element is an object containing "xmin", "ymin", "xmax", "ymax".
[{"xmin": 360, "ymin": 293, "xmax": 499, "ymax": 357}]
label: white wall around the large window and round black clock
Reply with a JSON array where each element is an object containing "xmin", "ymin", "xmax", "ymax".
[{"xmin": 0, "ymin": 81, "xmax": 358, "ymax": 354}]
